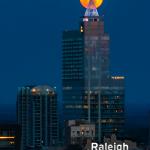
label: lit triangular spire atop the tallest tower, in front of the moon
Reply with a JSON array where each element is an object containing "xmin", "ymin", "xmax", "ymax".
[{"xmin": 84, "ymin": 0, "xmax": 99, "ymax": 17}]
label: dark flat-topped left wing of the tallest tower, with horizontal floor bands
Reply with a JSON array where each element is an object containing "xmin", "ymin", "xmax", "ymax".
[{"xmin": 62, "ymin": 30, "xmax": 84, "ymax": 120}]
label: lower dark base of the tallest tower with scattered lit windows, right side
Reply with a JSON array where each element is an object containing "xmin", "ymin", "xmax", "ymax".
[{"xmin": 83, "ymin": 76, "xmax": 125, "ymax": 138}]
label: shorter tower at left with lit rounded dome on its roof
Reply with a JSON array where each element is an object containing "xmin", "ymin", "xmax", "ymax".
[{"xmin": 17, "ymin": 86, "xmax": 58, "ymax": 150}]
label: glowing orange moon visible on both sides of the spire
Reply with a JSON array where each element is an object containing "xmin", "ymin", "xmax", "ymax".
[{"xmin": 80, "ymin": 0, "xmax": 103, "ymax": 8}]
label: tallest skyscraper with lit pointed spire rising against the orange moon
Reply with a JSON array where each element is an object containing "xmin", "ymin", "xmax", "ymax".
[{"xmin": 62, "ymin": 0, "xmax": 125, "ymax": 140}]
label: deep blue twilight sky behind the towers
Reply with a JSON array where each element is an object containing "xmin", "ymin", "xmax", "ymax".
[{"xmin": 0, "ymin": 0, "xmax": 150, "ymax": 124}]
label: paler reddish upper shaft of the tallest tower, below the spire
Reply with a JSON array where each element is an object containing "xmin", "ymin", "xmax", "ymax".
[{"xmin": 82, "ymin": 17, "xmax": 109, "ymax": 91}]
